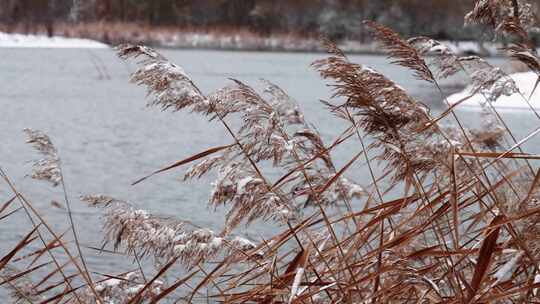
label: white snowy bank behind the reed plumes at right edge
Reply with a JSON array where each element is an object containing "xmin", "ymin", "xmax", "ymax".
[{"xmin": 448, "ymin": 72, "xmax": 540, "ymax": 110}]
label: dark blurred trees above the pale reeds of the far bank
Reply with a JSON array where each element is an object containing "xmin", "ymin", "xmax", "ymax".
[{"xmin": 0, "ymin": 0, "xmax": 540, "ymax": 40}]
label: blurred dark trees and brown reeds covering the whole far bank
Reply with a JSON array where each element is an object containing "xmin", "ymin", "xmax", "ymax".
[{"xmin": 0, "ymin": 0, "xmax": 540, "ymax": 55}]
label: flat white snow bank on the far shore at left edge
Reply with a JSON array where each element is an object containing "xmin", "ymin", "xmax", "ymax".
[{"xmin": 0, "ymin": 32, "xmax": 109, "ymax": 49}]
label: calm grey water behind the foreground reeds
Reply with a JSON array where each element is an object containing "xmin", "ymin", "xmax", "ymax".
[{"xmin": 0, "ymin": 49, "xmax": 540, "ymax": 294}]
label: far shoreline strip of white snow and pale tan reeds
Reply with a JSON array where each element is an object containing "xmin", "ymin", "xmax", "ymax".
[{"xmin": 0, "ymin": 30, "xmax": 536, "ymax": 56}]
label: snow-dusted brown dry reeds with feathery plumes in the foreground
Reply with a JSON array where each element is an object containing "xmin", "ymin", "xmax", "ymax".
[{"xmin": 0, "ymin": 0, "xmax": 540, "ymax": 303}]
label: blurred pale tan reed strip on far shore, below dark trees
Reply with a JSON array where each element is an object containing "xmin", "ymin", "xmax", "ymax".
[{"xmin": 0, "ymin": 22, "xmax": 536, "ymax": 56}]
